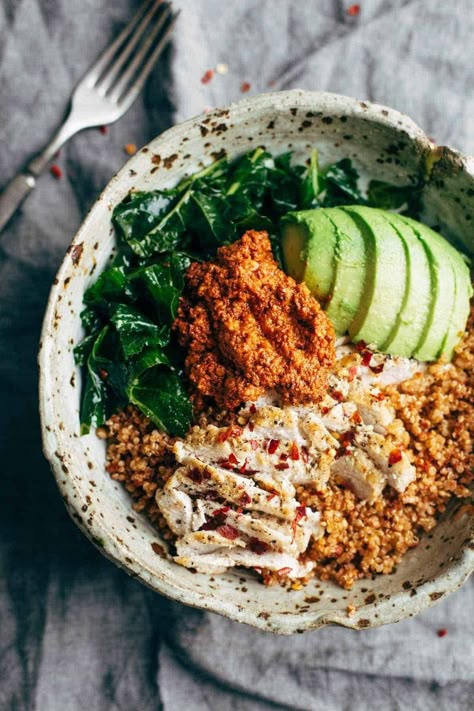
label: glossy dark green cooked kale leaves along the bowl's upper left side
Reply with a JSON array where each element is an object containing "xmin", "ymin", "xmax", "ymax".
[{"xmin": 75, "ymin": 148, "xmax": 419, "ymax": 436}]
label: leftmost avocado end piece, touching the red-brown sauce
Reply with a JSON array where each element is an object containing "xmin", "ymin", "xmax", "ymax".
[{"xmin": 282, "ymin": 209, "xmax": 337, "ymax": 302}]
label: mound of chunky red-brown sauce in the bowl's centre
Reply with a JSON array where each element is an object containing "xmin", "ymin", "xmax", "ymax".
[{"xmin": 174, "ymin": 230, "xmax": 335, "ymax": 409}]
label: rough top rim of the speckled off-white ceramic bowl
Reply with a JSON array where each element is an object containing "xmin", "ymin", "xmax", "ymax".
[{"xmin": 39, "ymin": 90, "xmax": 474, "ymax": 634}]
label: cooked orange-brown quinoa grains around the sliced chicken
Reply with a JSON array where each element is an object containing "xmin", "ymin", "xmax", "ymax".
[{"xmin": 102, "ymin": 312, "xmax": 474, "ymax": 588}]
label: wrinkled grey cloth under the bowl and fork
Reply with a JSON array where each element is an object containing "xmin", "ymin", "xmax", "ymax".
[{"xmin": 0, "ymin": 0, "xmax": 474, "ymax": 711}]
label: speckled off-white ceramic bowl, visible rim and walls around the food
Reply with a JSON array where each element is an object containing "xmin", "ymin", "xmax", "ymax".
[{"xmin": 39, "ymin": 90, "xmax": 474, "ymax": 634}]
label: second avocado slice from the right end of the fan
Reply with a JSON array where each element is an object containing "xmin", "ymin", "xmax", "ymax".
[{"xmin": 381, "ymin": 212, "xmax": 432, "ymax": 357}]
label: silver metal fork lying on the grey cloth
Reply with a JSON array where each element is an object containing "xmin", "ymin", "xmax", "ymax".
[{"xmin": 0, "ymin": 0, "xmax": 179, "ymax": 232}]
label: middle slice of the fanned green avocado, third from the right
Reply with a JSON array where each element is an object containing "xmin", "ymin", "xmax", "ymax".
[{"xmin": 341, "ymin": 206, "xmax": 407, "ymax": 348}]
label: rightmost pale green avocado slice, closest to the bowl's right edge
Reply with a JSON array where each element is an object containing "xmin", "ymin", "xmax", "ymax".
[{"xmin": 400, "ymin": 216, "xmax": 473, "ymax": 360}]
